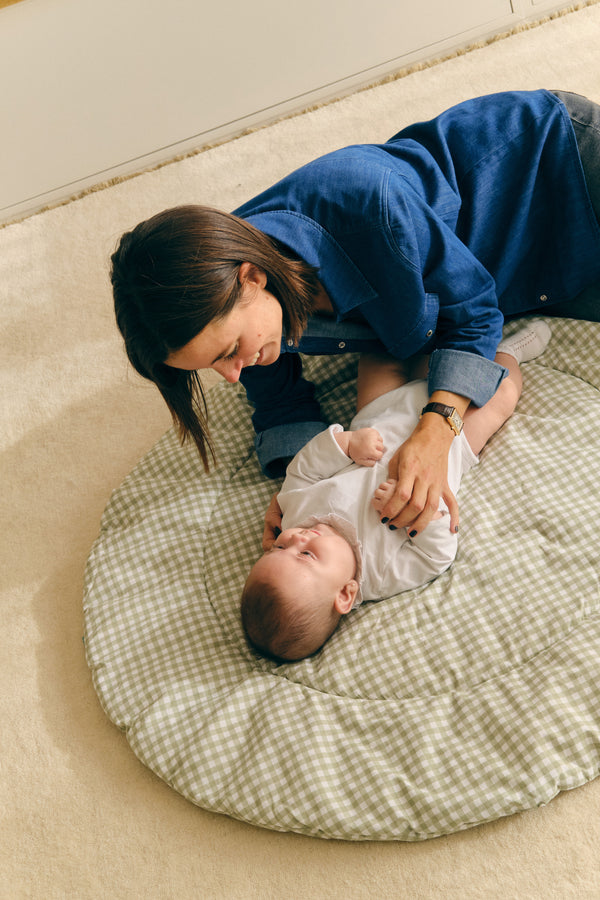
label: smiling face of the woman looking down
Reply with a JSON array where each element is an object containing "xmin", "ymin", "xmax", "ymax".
[{"xmin": 165, "ymin": 263, "xmax": 283, "ymax": 382}]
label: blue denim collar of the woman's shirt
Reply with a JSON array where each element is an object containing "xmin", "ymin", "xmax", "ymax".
[{"xmin": 246, "ymin": 209, "xmax": 377, "ymax": 321}]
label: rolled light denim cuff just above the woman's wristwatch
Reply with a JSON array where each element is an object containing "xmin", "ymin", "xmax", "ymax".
[{"xmin": 427, "ymin": 350, "xmax": 508, "ymax": 406}]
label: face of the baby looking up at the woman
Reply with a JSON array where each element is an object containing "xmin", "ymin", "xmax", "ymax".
[{"xmin": 253, "ymin": 523, "xmax": 356, "ymax": 602}]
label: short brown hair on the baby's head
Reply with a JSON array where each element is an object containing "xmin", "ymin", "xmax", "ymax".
[{"xmin": 241, "ymin": 573, "xmax": 340, "ymax": 662}]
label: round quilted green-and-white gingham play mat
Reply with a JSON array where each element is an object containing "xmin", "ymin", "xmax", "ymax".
[{"xmin": 84, "ymin": 320, "xmax": 600, "ymax": 841}]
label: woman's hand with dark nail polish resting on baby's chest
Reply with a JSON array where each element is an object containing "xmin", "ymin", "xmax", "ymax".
[{"xmin": 380, "ymin": 414, "xmax": 458, "ymax": 537}]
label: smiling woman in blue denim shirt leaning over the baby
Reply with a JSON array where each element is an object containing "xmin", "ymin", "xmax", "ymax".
[{"xmin": 112, "ymin": 90, "xmax": 600, "ymax": 534}]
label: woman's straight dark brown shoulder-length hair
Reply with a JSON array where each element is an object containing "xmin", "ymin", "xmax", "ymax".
[{"xmin": 111, "ymin": 206, "xmax": 319, "ymax": 471}]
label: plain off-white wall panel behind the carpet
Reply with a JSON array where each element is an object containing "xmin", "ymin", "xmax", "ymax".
[{"xmin": 0, "ymin": 0, "xmax": 567, "ymax": 221}]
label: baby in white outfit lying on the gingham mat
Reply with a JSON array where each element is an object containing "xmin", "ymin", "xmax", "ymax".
[{"xmin": 242, "ymin": 321, "xmax": 550, "ymax": 661}]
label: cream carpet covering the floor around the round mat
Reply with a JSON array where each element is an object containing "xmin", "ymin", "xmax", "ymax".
[{"xmin": 0, "ymin": 4, "xmax": 600, "ymax": 900}]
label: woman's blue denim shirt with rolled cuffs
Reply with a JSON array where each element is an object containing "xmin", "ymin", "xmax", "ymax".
[{"xmin": 235, "ymin": 90, "xmax": 600, "ymax": 476}]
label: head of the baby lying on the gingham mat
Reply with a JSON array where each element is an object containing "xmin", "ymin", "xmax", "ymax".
[{"xmin": 242, "ymin": 523, "xmax": 358, "ymax": 661}]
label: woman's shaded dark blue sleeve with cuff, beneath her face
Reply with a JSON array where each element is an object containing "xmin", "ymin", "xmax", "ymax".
[{"xmin": 240, "ymin": 353, "xmax": 328, "ymax": 478}]
